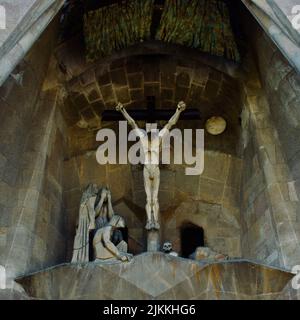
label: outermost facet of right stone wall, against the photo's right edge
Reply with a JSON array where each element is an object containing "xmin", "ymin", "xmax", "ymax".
[{"xmin": 256, "ymin": 33, "xmax": 300, "ymax": 207}]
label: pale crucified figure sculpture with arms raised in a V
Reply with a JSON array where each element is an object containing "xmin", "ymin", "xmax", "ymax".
[{"xmin": 116, "ymin": 101, "xmax": 186, "ymax": 230}]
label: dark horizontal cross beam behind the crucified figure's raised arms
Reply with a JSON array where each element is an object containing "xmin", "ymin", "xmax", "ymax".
[{"xmin": 102, "ymin": 96, "xmax": 201, "ymax": 123}]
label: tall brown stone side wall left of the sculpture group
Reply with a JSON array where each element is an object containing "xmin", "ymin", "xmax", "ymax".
[{"xmin": 0, "ymin": 20, "xmax": 65, "ymax": 278}]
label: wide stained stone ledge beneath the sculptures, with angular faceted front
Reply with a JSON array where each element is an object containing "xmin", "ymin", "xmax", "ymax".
[{"xmin": 17, "ymin": 253, "xmax": 293, "ymax": 300}]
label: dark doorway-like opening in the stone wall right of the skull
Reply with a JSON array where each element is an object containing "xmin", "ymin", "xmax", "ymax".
[{"xmin": 180, "ymin": 222, "xmax": 204, "ymax": 258}]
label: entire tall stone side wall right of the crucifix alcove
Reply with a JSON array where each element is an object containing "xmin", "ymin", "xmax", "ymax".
[{"xmin": 242, "ymin": 10, "xmax": 300, "ymax": 268}]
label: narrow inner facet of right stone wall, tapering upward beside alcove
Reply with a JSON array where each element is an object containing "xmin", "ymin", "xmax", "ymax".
[{"xmin": 241, "ymin": 92, "xmax": 282, "ymax": 266}]
